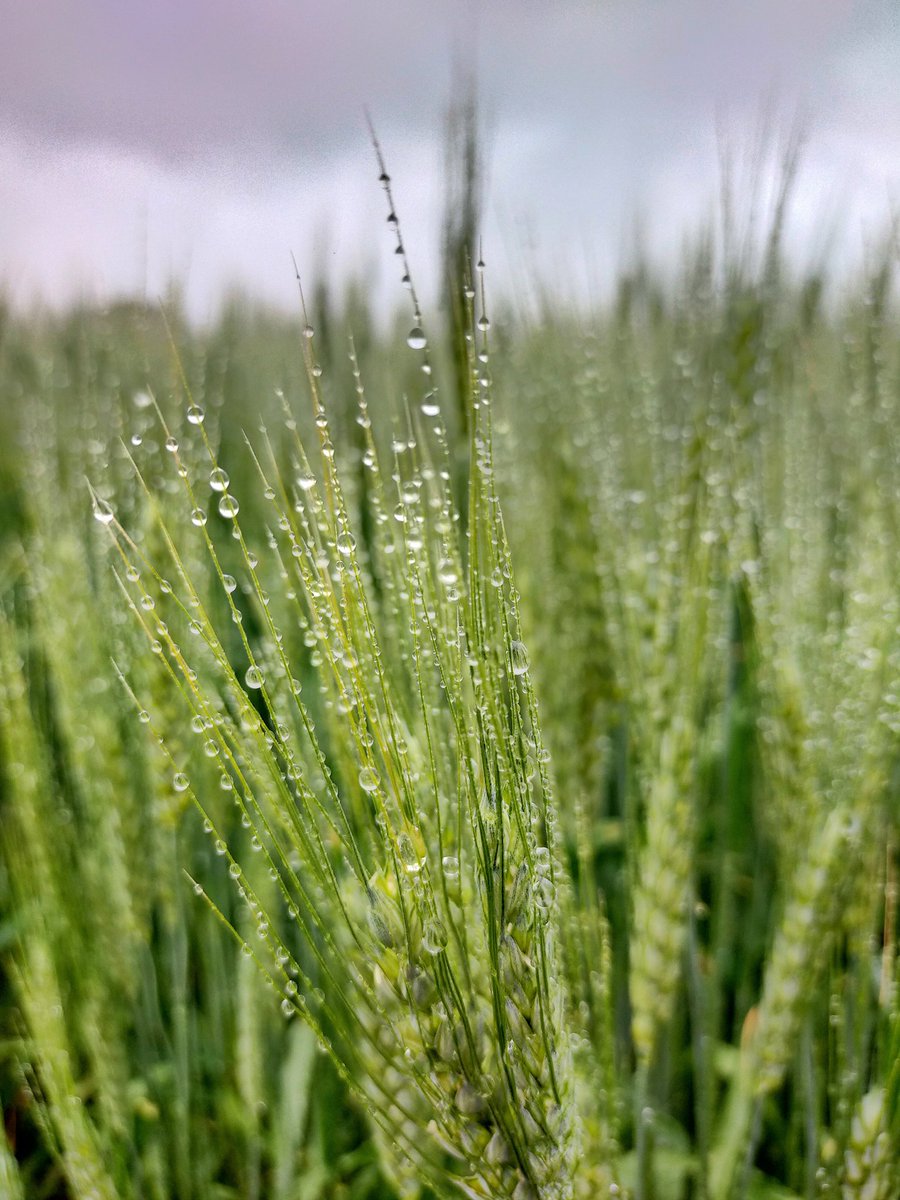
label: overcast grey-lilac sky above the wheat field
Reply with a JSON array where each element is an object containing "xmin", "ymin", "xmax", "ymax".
[{"xmin": 0, "ymin": 0, "xmax": 900, "ymax": 317}]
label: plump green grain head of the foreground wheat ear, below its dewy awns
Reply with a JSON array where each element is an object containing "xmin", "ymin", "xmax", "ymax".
[{"xmin": 348, "ymin": 825, "xmax": 578, "ymax": 1200}]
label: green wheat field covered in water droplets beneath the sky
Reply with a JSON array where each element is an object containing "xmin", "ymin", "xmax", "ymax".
[{"xmin": 0, "ymin": 152, "xmax": 900, "ymax": 1200}]
